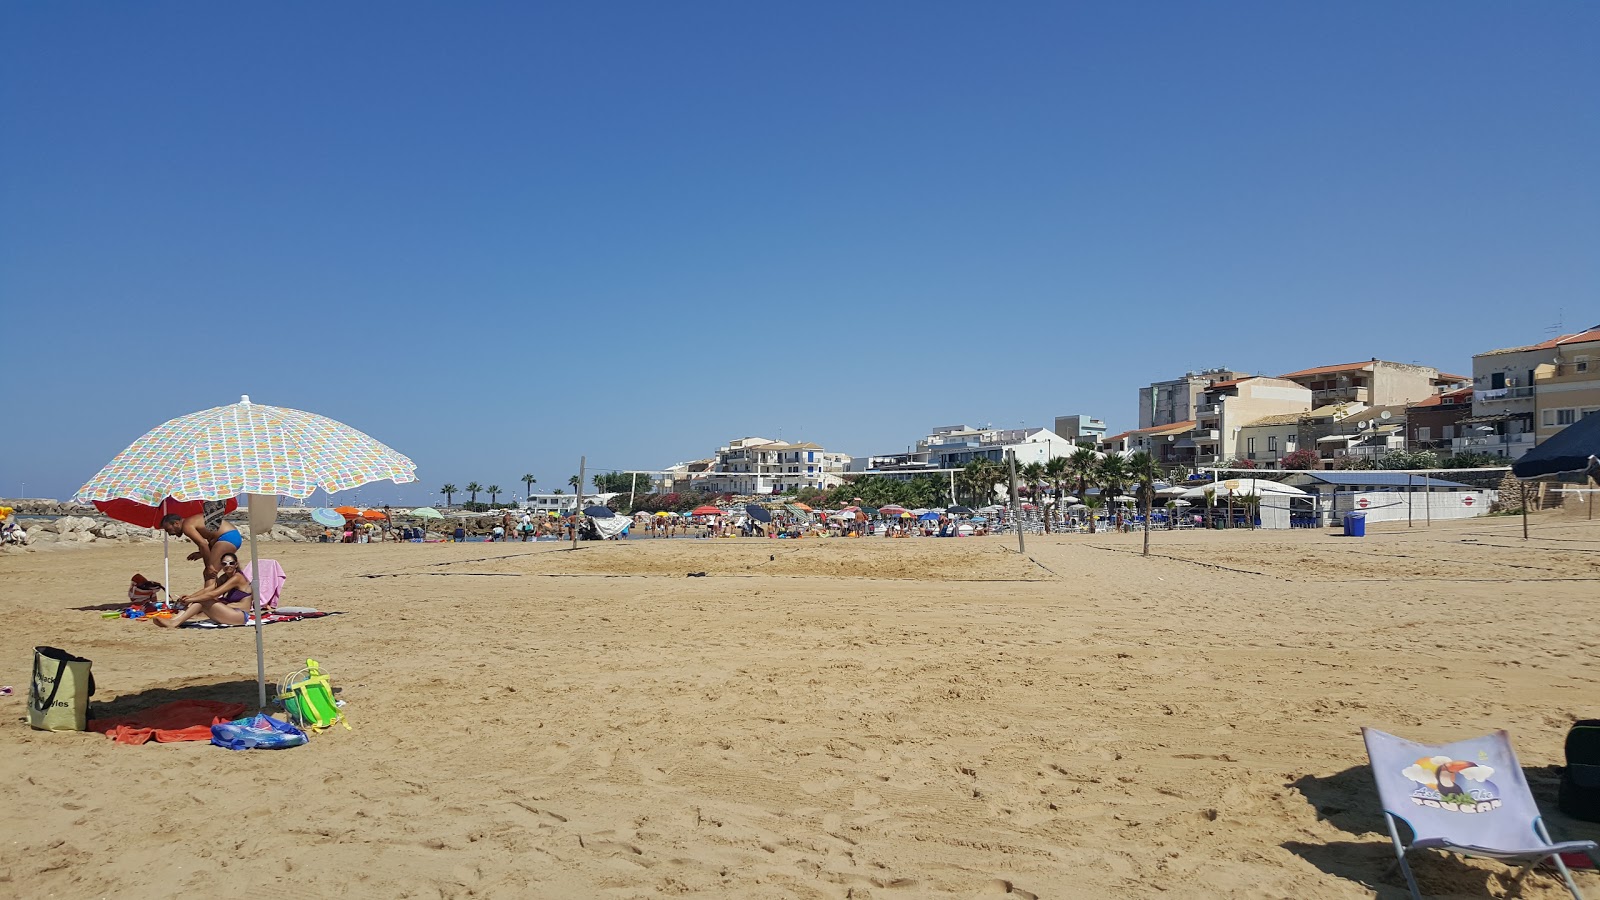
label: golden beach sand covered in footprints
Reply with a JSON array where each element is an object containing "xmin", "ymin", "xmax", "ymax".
[{"xmin": 0, "ymin": 517, "xmax": 1600, "ymax": 898}]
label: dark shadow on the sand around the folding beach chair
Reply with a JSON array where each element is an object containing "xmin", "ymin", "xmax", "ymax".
[{"xmin": 1280, "ymin": 765, "xmax": 1600, "ymax": 900}]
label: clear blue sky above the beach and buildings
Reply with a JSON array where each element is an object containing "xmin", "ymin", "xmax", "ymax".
[{"xmin": 0, "ymin": 2, "xmax": 1600, "ymax": 503}]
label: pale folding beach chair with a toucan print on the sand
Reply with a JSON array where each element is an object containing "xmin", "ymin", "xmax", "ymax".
[{"xmin": 1362, "ymin": 729, "xmax": 1595, "ymax": 900}]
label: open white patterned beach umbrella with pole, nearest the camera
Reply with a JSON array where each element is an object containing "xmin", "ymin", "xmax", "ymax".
[{"xmin": 77, "ymin": 396, "xmax": 416, "ymax": 709}]
